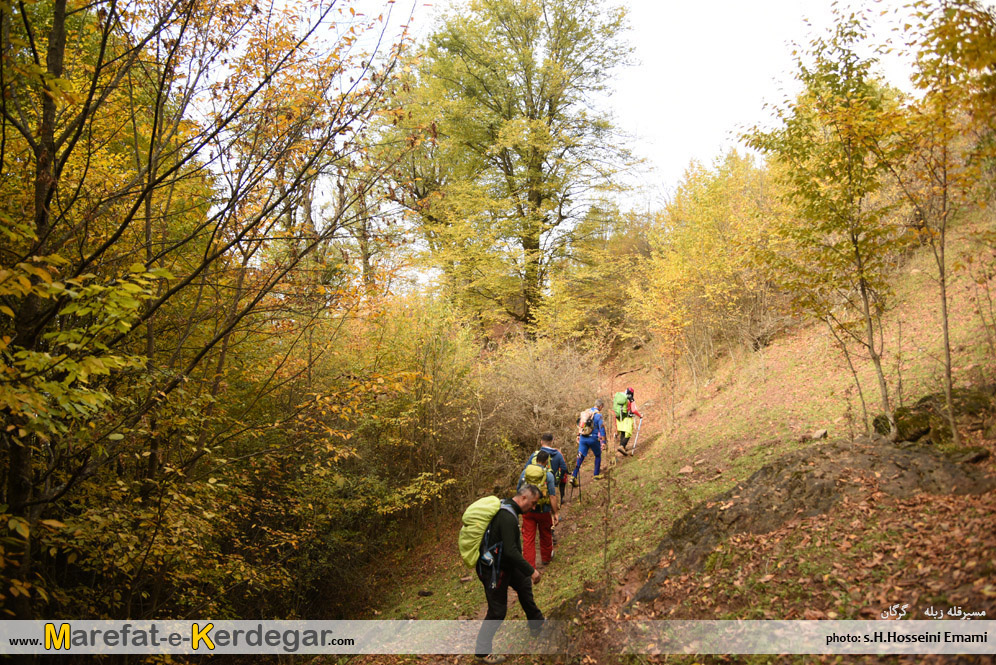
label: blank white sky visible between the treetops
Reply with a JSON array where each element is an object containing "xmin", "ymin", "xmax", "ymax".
[{"xmin": 390, "ymin": 0, "xmax": 920, "ymax": 208}]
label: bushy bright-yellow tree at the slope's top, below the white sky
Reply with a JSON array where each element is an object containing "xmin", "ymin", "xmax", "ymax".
[{"xmin": 635, "ymin": 151, "xmax": 780, "ymax": 408}]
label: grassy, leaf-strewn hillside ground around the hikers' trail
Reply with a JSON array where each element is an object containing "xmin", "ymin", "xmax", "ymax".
[{"xmin": 317, "ymin": 213, "xmax": 996, "ymax": 664}]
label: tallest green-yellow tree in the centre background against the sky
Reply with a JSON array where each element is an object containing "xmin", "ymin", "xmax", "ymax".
[{"xmin": 398, "ymin": 0, "xmax": 629, "ymax": 326}]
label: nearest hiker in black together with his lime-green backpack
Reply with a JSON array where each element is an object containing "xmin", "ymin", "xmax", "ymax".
[{"xmin": 459, "ymin": 484, "xmax": 546, "ymax": 663}]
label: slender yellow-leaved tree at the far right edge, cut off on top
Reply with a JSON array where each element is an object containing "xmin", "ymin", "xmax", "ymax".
[{"xmin": 871, "ymin": 0, "xmax": 996, "ymax": 445}]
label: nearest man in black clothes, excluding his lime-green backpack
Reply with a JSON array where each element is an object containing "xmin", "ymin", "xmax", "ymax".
[{"xmin": 477, "ymin": 484, "xmax": 545, "ymax": 663}]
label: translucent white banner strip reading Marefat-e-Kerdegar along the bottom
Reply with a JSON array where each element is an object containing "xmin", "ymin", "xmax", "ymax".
[{"xmin": 0, "ymin": 619, "xmax": 996, "ymax": 655}]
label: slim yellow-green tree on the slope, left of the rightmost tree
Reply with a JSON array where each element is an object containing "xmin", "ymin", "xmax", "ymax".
[{"xmin": 747, "ymin": 15, "xmax": 903, "ymax": 432}]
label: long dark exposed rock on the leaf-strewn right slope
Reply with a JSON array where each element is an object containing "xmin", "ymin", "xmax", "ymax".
[{"xmin": 631, "ymin": 437, "xmax": 996, "ymax": 604}]
